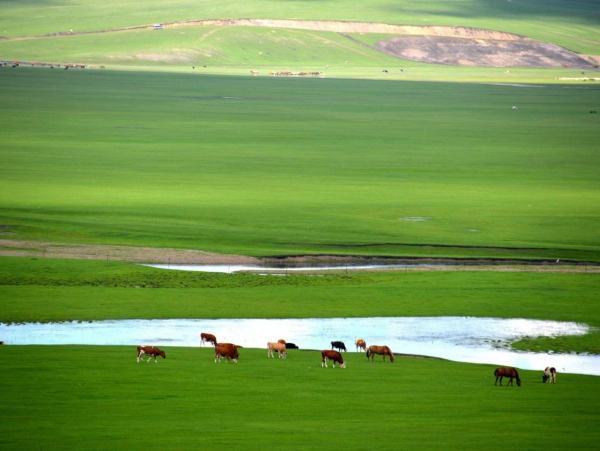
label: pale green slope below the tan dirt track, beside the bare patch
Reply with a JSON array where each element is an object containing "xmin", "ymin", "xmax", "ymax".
[{"xmin": 0, "ymin": 26, "xmax": 594, "ymax": 83}]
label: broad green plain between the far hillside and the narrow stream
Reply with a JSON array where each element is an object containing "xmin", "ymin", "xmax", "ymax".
[{"xmin": 0, "ymin": 69, "xmax": 600, "ymax": 260}]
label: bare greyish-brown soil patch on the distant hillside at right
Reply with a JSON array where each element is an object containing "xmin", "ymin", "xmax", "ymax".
[{"xmin": 376, "ymin": 36, "xmax": 594, "ymax": 68}]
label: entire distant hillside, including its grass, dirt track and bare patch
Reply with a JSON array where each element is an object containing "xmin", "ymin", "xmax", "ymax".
[{"xmin": 0, "ymin": 0, "xmax": 600, "ymax": 82}]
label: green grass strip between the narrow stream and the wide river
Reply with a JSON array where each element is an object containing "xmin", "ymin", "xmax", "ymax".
[{"xmin": 0, "ymin": 257, "xmax": 600, "ymax": 353}]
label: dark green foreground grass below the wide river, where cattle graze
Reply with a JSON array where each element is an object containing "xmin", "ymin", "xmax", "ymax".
[{"xmin": 0, "ymin": 346, "xmax": 600, "ymax": 449}]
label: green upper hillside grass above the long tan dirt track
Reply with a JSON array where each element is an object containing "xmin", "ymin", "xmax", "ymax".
[{"xmin": 0, "ymin": 0, "xmax": 600, "ymax": 54}]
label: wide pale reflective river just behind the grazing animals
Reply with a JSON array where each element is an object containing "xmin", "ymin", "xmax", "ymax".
[{"xmin": 0, "ymin": 317, "xmax": 600, "ymax": 375}]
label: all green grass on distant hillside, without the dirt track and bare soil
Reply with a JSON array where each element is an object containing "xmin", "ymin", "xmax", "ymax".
[{"xmin": 0, "ymin": 0, "xmax": 600, "ymax": 83}]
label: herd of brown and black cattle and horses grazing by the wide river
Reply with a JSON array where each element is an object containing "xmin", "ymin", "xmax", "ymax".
[{"xmin": 135, "ymin": 332, "xmax": 556, "ymax": 387}]
